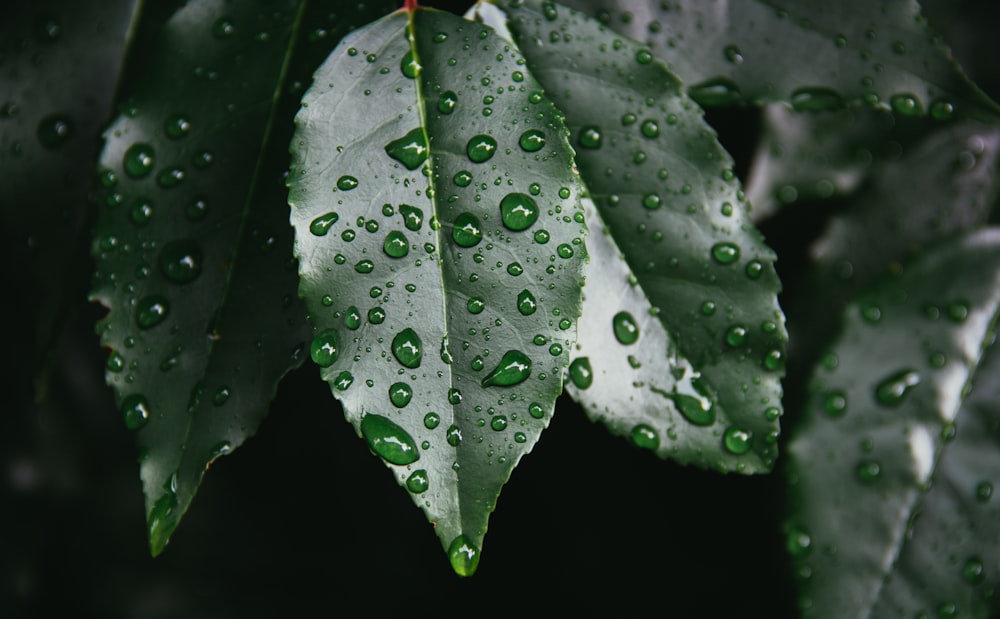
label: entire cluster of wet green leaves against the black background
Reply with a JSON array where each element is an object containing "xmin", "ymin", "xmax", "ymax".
[{"xmin": 0, "ymin": 0, "xmax": 1000, "ymax": 616}]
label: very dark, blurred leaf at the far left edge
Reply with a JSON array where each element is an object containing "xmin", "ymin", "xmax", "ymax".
[{"xmin": 0, "ymin": 0, "xmax": 136, "ymax": 397}]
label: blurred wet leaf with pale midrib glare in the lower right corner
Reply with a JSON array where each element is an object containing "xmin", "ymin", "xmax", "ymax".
[{"xmin": 786, "ymin": 228, "xmax": 1000, "ymax": 617}]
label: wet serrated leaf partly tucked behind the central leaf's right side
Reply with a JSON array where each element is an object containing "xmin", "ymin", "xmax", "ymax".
[{"xmin": 482, "ymin": 1, "xmax": 786, "ymax": 473}]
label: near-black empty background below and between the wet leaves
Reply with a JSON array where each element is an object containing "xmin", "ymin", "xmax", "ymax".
[{"xmin": 0, "ymin": 0, "xmax": 1000, "ymax": 619}]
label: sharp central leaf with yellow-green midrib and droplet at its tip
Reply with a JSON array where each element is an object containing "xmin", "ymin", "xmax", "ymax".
[{"xmin": 289, "ymin": 9, "xmax": 587, "ymax": 575}]
